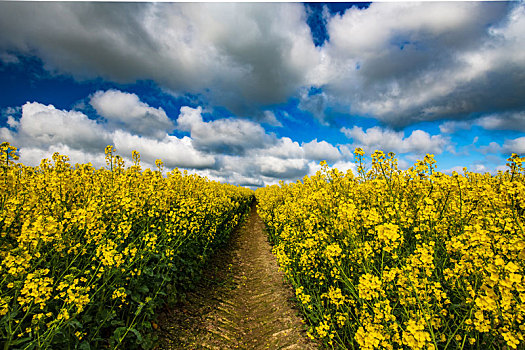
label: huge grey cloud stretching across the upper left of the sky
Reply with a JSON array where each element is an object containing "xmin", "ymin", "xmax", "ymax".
[{"xmin": 0, "ymin": 3, "xmax": 320, "ymax": 115}]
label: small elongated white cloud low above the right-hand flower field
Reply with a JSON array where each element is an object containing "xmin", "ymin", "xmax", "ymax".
[{"xmin": 341, "ymin": 126, "xmax": 449, "ymax": 154}]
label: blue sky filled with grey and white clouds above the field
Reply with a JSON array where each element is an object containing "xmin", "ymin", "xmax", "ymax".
[{"xmin": 0, "ymin": 1, "xmax": 525, "ymax": 186}]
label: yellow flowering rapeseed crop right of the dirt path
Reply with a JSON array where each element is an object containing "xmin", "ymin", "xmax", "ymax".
[{"xmin": 256, "ymin": 149, "xmax": 525, "ymax": 350}]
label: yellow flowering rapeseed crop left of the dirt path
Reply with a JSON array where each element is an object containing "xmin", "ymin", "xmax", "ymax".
[{"xmin": 0, "ymin": 143, "xmax": 253, "ymax": 349}]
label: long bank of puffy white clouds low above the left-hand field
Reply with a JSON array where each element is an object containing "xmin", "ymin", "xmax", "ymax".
[{"xmin": 0, "ymin": 90, "xmax": 352, "ymax": 187}]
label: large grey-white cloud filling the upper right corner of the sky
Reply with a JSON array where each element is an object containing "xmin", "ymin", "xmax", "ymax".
[{"xmin": 312, "ymin": 2, "xmax": 525, "ymax": 126}]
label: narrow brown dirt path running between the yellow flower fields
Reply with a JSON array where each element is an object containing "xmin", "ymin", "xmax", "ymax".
[{"xmin": 158, "ymin": 206, "xmax": 317, "ymax": 349}]
